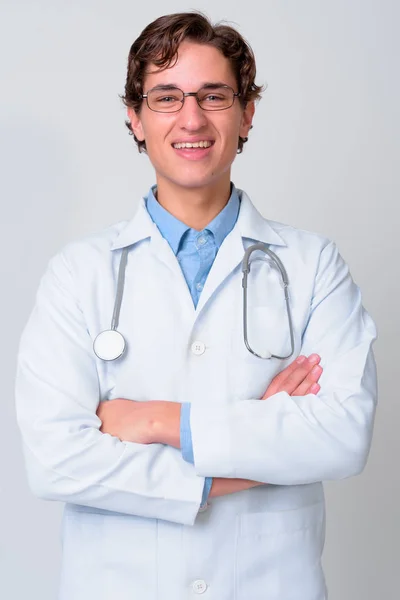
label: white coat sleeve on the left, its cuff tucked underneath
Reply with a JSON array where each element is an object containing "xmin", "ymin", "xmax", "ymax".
[{"xmin": 16, "ymin": 253, "xmax": 205, "ymax": 525}]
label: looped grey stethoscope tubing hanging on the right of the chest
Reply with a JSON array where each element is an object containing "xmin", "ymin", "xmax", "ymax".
[{"xmin": 242, "ymin": 242, "xmax": 294, "ymax": 360}]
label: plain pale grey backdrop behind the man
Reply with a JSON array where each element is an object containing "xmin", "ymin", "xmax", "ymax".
[{"xmin": 0, "ymin": 0, "xmax": 400, "ymax": 600}]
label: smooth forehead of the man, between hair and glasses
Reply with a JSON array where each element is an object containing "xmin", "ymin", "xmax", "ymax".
[{"xmin": 144, "ymin": 42, "xmax": 236, "ymax": 91}]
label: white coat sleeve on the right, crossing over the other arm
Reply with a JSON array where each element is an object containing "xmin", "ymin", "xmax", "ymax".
[{"xmin": 190, "ymin": 242, "xmax": 377, "ymax": 485}]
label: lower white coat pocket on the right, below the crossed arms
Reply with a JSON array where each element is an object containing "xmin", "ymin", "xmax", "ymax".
[{"xmin": 235, "ymin": 502, "xmax": 326, "ymax": 600}]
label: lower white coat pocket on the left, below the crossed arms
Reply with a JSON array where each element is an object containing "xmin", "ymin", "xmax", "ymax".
[{"xmin": 60, "ymin": 505, "xmax": 157, "ymax": 600}]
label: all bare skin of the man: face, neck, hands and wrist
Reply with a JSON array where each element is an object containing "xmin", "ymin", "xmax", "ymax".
[{"xmin": 97, "ymin": 41, "xmax": 322, "ymax": 497}]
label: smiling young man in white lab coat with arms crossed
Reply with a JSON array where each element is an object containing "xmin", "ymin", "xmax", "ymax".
[{"xmin": 17, "ymin": 13, "xmax": 376, "ymax": 600}]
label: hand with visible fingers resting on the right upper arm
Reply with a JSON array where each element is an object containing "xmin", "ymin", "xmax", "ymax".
[{"xmin": 261, "ymin": 354, "xmax": 322, "ymax": 400}]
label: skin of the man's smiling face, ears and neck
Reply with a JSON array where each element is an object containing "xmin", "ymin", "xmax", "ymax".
[{"xmin": 128, "ymin": 42, "xmax": 254, "ymax": 231}]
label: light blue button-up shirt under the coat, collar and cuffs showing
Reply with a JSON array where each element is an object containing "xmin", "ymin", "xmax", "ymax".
[{"xmin": 146, "ymin": 183, "xmax": 240, "ymax": 504}]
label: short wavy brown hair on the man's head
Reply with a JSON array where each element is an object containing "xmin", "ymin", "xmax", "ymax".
[{"xmin": 121, "ymin": 11, "xmax": 264, "ymax": 154}]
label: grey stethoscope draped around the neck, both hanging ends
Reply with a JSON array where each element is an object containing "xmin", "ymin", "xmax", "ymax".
[{"xmin": 93, "ymin": 242, "xmax": 294, "ymax": 361}]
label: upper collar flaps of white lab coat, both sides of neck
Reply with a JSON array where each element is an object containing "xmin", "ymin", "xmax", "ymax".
[{"xmin": 111, "ymin": 189, "xmax": 286, "ymax": 250}]
